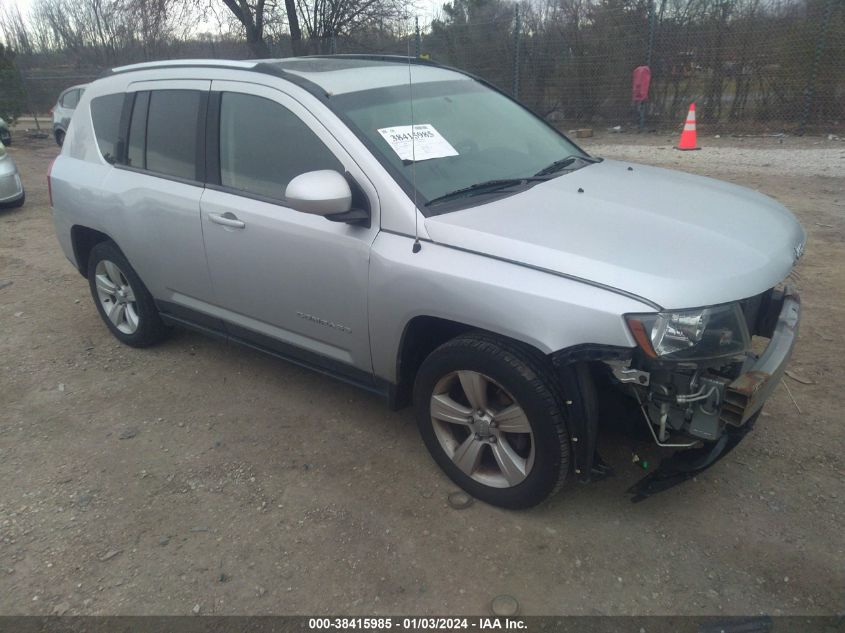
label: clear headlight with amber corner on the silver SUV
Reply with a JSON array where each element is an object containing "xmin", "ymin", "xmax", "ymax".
[{"xmin": 625, "ymin": 303, "xmax": 751, "ymax": 360}]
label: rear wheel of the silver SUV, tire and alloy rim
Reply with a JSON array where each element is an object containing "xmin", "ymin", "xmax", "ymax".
[{"xmin": 88, "ymin": 241, "xmax": 167, "ymax": 347}]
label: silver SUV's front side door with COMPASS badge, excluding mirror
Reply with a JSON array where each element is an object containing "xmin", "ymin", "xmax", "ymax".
[{"xmin": 202, "ymin": 81, "xmax": 378, "ymax": 381}]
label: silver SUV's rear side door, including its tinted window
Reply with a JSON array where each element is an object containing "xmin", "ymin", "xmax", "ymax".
[{"xmin": 110, "ymin": 80, "xmax": 218, "ymax": 317}]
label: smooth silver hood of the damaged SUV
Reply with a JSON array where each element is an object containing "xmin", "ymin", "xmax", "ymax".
[{"xmin": 425, "ymin": 160, "xmax": 805, "ymax": 309}]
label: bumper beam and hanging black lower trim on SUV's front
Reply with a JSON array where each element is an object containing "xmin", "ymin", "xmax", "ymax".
[{"xmin": 628, "ymin": 287, "xmax": 801, "ymax": 501}]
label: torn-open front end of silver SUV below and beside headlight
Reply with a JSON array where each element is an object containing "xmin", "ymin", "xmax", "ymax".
[{"xmin": 606, "ymin": 287, "xmax": 801, "ymax": 500}]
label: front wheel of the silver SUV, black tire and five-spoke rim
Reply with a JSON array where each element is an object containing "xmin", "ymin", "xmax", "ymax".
[{"xmin": 414, "ymin": 333, "xmax": 570, "ymax": 509}]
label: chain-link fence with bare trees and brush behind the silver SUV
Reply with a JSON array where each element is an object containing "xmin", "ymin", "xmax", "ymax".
[{"xmin": 6, "ymin": 0, "xmax": 845, "ymax": 133}]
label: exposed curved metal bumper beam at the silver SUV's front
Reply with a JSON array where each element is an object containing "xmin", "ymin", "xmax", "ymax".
[{"xmin": 720, "ymin": 287, "xmax": 801, "ymax": 426}]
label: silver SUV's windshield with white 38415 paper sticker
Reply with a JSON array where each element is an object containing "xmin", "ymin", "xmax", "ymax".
[{"xmin": 332, "ymin": 79, "xmax": 584, "ymax": 213}]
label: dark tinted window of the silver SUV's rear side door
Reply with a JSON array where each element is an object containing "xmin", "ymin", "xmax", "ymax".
[{"xmin": 128, "ymin": 90, "xmax": 204, "ymax": 180}]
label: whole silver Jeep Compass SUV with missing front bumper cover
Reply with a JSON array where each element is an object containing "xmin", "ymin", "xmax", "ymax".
[{"xmin": 49, "ymin": 56, "xmax": 805, "ymax": 508}]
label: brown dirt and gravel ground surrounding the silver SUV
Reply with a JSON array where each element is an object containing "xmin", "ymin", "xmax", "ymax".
[{"xmin": 0, "ymin": 135, "xmax": 845, "ymax": 615}]
